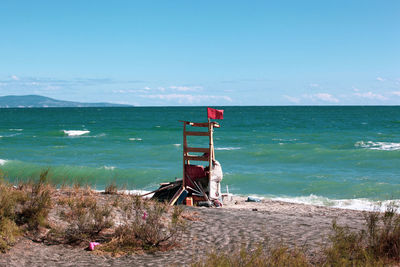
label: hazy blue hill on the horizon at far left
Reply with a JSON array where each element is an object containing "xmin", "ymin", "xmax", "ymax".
[{"xmin": 0, "ymin": 95, "xmax": 130, "ymax": 108}]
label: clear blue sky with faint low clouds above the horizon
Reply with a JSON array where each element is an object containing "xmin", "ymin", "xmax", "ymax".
[{"xmin": 0, "ymin": 0, "xmax": 400, "ymax": 106}]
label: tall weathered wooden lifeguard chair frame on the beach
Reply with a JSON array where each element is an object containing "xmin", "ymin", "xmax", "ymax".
[{"xmin": 169, "ymin": 120, "xmax": 220, "ymax": 205}]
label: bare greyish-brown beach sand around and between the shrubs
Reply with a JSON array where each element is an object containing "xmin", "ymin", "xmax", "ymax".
[{"xmin": 0, "ymin": 197, "xmax": 364, "ymax": 266}]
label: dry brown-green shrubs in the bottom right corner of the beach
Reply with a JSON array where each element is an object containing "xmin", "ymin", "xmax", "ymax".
[{"xmin": 324, "ymin": 205, "xmax": 400, "ymax": 266}]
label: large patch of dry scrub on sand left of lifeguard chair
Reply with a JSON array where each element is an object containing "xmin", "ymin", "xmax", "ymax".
[{"xmin": 0, "ymin": 176, "xmax": 186, "ymax": 255}]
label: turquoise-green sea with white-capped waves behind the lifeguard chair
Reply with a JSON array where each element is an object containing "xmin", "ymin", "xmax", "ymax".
[{"xmin": 0, "ymin": 106, "xmax": 400, "ymax": 210}]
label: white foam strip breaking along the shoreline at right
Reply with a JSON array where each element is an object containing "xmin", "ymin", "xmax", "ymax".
[{"xmin": 271, "ymin": 194, "xmax": 400, "ymax": 214}]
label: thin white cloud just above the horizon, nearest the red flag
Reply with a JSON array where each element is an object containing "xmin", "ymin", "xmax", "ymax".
[{"xmin": 140, "ymin": 94, "xmax": 232, "ymax": 104}]
